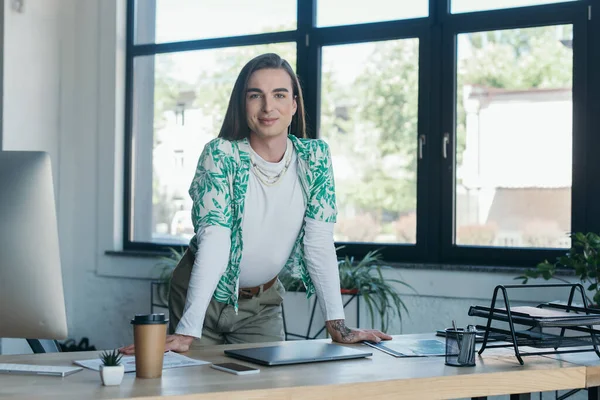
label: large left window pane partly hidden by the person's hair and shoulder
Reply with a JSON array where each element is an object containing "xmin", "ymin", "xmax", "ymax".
[{"xmin": 130, "ymin": 43, "xmax": 296, "ymax": 244}]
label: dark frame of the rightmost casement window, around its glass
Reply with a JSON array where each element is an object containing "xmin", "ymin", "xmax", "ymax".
[{"xmin": 439, "ymin": 2, "xmax": 587, "ymax": 266}]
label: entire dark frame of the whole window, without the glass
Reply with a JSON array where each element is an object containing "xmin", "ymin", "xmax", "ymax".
[{"xmin": 123, "ymin": 0, "xmax": 600, "ymax": 266}]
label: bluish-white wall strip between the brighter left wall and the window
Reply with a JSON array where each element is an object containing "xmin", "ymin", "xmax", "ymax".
[{"xmin": 59, "ymin": 0, "xmax": 155, "ymax": 348}]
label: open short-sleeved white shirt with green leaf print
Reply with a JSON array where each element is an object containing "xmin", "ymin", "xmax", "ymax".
[{"xmin": 189, "ymin": 135, "xmax": 337, "ymax": 312}]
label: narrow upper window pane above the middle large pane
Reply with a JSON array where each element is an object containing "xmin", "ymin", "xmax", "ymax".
[{"xmin": 317, "ymin": 0, "xmax": 429, "ymax": 26}]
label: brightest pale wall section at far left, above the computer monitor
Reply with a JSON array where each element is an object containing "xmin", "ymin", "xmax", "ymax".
[{"xmin": 1, "ymin": 0, "xmax": 72, "ymax": 352}]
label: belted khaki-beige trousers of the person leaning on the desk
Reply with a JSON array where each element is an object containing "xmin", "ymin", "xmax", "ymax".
[{"xmin": 169, "ymin": 249, "xmax": 285, "ymax": 348}]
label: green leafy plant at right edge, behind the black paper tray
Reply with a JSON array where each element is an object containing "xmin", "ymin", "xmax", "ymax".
[{"xmin": 515, "ymin": 232, "xmax": 600, "ymax": 307}]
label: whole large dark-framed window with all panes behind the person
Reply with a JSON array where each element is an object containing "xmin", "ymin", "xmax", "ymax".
[{"xmin": 124, "ymin": 0, "xmax": 600, "ymax": 265}]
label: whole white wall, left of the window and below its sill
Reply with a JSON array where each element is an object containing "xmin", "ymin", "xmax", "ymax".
[{"xmin": 3, "ymin": 0, "xmax": 584, "ymax": 351}]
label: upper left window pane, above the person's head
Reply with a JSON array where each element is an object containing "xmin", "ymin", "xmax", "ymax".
[{"xmin": 135, "ymin": 0, "xmax": 296, "ymax": 44}]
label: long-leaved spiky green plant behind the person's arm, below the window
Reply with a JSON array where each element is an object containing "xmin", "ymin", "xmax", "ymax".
[{"xmin": 279, "ymin": 248, "xmax": 414, "ymax": 332}]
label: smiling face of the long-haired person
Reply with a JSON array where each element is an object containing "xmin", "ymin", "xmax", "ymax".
[{"xmin": 246, "ymin": 69, "xmax": 298, "ymax": 138}]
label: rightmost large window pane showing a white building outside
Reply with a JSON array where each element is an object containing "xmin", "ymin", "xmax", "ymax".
[{"xmin": 455, "ymin": 25, "xmax": 573, "ymax": 248}]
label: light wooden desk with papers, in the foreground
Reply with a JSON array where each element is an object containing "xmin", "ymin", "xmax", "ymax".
[{"xmin": 0, "ymin": 335, "xmax": 586, "ymax": 400}]
